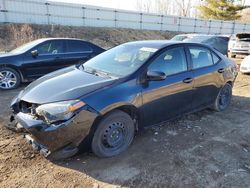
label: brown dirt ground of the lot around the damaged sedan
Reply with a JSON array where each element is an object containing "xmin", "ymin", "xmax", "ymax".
[{"xmin": 0, "ymin": 57, "xmax": 250, "ymax": 188}]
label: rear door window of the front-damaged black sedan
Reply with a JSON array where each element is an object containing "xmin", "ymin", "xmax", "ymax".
[{"xmin": 189, "ymin": 47, "xmax": 214, "ymax": 69}]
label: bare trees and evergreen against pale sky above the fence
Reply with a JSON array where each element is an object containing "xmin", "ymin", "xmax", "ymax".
[{"xmin": 136, "ymin": 0, "xmax": 249, "ymax": 20}]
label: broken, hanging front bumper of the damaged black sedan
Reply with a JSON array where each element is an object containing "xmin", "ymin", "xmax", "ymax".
[{"xmin": 10, "ymin": 107, "xmax": 98, "ymax": 159}]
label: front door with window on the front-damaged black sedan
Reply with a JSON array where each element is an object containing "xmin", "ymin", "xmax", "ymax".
[{"xmin": 141, "ymin": 46, "xmax": 193, "ymax": 126}]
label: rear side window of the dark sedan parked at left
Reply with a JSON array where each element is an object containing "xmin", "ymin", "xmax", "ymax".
[{"xmin": 67, "ymin": 41, "xmax": 93, "ymax": 53}]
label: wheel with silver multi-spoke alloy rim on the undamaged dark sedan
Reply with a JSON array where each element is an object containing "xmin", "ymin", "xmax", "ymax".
[{"xmin": 0, "ymin": 67, "xmax": 21, "ymax": 90}]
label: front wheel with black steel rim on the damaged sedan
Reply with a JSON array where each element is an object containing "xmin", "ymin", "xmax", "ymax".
[{"xmin": 91, "ymin": 110, "xmax": 135, "ymax": 157}]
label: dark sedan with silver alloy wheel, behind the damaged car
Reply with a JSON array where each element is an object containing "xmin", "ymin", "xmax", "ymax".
[{"xmin": 0, "ymin": 38, "xmax": 104, "ymax": 90}]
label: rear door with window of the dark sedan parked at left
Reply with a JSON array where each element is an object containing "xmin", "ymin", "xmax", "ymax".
[{"xmin": 65, "ymin": 40, "xmax": 95, "ymax": 66}]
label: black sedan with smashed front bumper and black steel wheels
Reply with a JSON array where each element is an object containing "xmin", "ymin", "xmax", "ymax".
[{"xmin": 9, "ymin": 41, "xmax": 237, "ymax": 158}]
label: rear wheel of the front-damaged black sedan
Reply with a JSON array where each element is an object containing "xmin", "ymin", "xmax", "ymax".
[{"xmin": 213, "ymin": 83, "xmax": 232, "ymax": 112}]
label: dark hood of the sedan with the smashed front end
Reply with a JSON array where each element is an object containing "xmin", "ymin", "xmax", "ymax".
[{"xmin": 17, "ymin": 66, "xmax": 116, "ymax": 104}]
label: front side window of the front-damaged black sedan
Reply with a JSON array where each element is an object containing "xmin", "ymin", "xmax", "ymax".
[{"xmin": 148, "ymin": 47, "xmax": 187, "ymax": 76}]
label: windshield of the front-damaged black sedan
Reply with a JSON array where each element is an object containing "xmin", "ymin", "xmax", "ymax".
[{"xmin": 84, "ymin": 44, "xmax": 158, "ymax": 77}]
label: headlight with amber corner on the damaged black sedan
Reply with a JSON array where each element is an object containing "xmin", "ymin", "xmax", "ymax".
[{"xmin": 36, "ymin": 100, "xmax": 85, "ymax": 123}]
